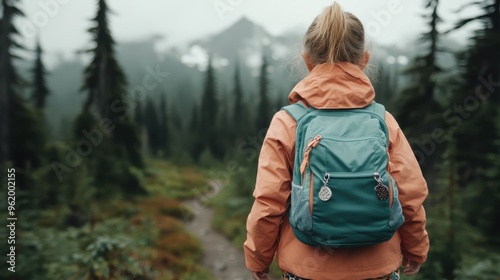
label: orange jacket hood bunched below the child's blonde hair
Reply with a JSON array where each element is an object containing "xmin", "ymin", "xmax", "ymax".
[{"xmin": 288, "ymin": 62, "xmax": 375, "ymax": 109}]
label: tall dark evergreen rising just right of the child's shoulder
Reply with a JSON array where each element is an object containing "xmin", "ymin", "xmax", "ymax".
[{"xmin": 396, "ymin": 0, "xmax": 445, "ymax": 182}]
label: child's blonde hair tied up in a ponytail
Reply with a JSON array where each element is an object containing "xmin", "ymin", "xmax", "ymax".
[{"xmin": 304, "ymin": 2, "xmax": 366, "ymax": 66}]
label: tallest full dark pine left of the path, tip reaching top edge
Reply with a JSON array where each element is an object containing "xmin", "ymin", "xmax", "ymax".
[{"xmin": 74, "ymin": 0, "xmax": 145, "ymax": 197}]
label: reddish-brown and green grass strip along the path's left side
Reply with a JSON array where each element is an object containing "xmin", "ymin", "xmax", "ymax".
[{"xmin": 135, "ymin": 160, "xmax": 214, "ymax": 280}]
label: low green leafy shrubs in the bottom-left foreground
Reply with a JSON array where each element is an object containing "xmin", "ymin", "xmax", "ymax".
[{"xmin": 1, "ymin": 218, "xmax": 154, "ymax": 280}]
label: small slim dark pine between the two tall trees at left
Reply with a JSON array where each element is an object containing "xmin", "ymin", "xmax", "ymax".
[{"xmin": 31, "ymin": 41, "xmax": 49, "ymax": 110}]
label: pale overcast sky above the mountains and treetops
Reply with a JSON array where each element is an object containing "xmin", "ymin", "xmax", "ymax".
[{"xmin": 18, "ymin": 0, "xmax": 477, "ymax": 66}]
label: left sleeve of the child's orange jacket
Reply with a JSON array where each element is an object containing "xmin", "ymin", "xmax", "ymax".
[{"xmin": 243, "ymin": 111, "xmax": 296, "ymax": 271}]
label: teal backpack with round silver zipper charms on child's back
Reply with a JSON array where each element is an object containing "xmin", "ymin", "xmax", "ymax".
[{"xmin": 283, "ymin": 102, "xmax": 404, "ymax": 248}]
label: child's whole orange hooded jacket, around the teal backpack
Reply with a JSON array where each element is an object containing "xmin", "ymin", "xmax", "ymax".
[{"xmin": 244, "ymin": 63, "xmax": 429, "ymax": 280}]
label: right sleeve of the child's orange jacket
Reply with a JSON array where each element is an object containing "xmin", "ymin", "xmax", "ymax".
[{"xmin": 386, "ymin": 110, "xmax": 429, "ymax": 263}]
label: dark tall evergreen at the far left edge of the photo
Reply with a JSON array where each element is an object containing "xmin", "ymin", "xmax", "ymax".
[{"xmin": 0, "ymin": 0, "xmax": 44, "ymax": 171}]
